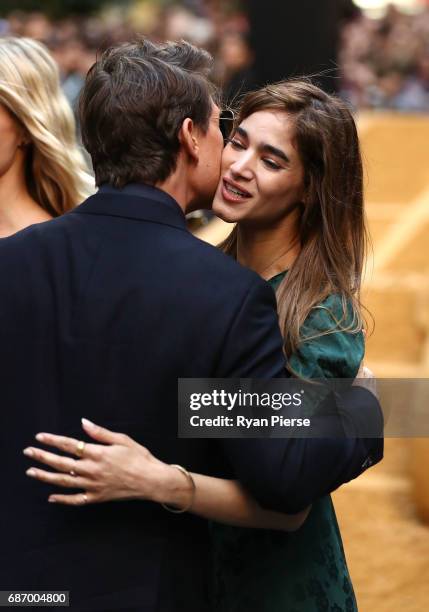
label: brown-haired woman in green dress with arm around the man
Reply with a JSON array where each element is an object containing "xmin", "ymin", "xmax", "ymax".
[{"xmin": 25, "ymin": 81, "xmax": 366, "ymax": 612}]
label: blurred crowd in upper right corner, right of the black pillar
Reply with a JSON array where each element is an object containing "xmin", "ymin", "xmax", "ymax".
[{"xmin": 339, "ymin": 5, "xmax": 429, "ymax": 111}]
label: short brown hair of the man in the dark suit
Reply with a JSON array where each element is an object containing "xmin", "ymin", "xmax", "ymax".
[{"xmin": 79, "ymin": 39, "xmax": 215, "ymax": 188}]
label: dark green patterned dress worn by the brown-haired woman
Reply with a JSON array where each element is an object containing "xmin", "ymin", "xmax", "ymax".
[{"xmin": 211, "ymin": 272, "xmax": 364, "ymax": 612}]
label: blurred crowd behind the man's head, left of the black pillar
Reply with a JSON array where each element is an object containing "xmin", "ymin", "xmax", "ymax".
[{"xmin": 0, "ymin": 2, "xmax": 252, "ymax": 110}]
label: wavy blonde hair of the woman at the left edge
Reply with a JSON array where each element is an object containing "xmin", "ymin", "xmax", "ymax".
[{"xmin": 0, "ymin": 37, "xmax": 94, "ymax": 217}]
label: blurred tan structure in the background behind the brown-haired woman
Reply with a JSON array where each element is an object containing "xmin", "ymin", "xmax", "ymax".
[{"xmin": 198, "ymin": 114, "xmax": 429, "ymax": 612}]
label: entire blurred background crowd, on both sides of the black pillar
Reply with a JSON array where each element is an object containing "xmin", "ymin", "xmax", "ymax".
[{"xmin": 0, "ymin": 0, "xmax": 429, "ymax": 111}]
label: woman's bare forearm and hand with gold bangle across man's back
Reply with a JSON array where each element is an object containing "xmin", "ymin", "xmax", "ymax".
[{"xmin": 24, "ymin": 419, "xmax": 310, "ymax": 531}]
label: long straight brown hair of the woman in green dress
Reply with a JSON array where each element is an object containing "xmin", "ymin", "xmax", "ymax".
[{"xmin": 220, "ymin": 80, "xmax": 367, "ymax": 364}]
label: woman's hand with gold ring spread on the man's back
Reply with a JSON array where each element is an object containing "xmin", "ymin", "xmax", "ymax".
[{"xmin": 24, "ymin": 419, "xmax": 191, "ymax": 506}]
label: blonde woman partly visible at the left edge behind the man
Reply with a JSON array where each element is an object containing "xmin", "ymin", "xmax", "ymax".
[{"xmin": 0, "ymin": 37, "xmax": 93, "ymax": 238}]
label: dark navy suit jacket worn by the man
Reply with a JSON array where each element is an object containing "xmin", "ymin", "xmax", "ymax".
[{"xmin": 0, "ymin": 185, "xmax": 382, "ymax": 612}]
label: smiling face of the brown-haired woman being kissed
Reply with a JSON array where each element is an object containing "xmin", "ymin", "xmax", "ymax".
[{"xmin": 213, "ymin": 111, "xmax": 304, "ymax": 225}]
